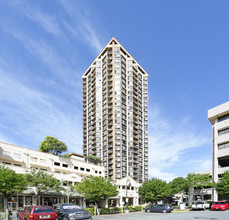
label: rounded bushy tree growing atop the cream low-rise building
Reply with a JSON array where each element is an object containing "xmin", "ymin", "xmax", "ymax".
[{"xmin": 39, "ymin": 136, "xmax": 67, "ymax": 155}]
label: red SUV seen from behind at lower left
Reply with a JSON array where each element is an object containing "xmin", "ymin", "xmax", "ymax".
[{"xmin": 17, "ymin": 205, "xmax": 57, "ymax": 220}]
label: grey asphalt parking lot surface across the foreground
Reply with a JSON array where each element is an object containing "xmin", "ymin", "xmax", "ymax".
[{"xmin": 93, "ymin": 210, "xmax": 229, "ymax": 220}]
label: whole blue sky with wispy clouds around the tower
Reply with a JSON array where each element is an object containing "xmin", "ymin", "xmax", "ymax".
[{"xmin": 0, "ymin": 0, "xmax": 229, "ymax": 180}]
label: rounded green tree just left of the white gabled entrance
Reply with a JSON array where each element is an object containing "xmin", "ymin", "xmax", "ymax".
[{"xmin": 75, "ymin": 176, "xmax": 118, "ymax": 213}]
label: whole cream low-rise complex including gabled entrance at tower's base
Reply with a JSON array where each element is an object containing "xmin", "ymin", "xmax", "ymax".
[{"xmin": 0, "ymin": 142, "xmax": 143, "ymax": 210}]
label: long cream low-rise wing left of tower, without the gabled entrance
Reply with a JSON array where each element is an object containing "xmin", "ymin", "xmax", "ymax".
[{"xmin": 0, "ymin": 142, "xmax": 104, "ymax": 210}]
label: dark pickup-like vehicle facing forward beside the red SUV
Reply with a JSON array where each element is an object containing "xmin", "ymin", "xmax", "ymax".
[{"xmin": 53, "ymin": 203, "xmax": 92, "ymax": 220}]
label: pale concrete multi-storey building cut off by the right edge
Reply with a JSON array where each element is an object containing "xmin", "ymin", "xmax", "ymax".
[{"xmin": 208, "ymin": 102, "xmax": 229, "ymax": 201}]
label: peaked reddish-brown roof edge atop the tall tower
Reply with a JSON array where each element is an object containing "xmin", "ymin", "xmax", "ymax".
[{"xmin": 82, "ymin": 37, "xmax": 148, "ymax": 78}]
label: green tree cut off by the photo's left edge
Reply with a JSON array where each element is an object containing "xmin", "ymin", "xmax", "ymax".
[{"xmin": 0, "ymin": 166, "xmax": 27, "ymax": 219}]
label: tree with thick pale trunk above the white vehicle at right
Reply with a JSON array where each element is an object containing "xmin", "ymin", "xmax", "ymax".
[{"xmin": 186, "ymin": 173, "xmax": 214, "ymax": 205}]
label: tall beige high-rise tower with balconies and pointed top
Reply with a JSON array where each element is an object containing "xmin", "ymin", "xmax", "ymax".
[{"xmin": 82, "ymin": 38, "xmax": 148, "ymax": 183}]
